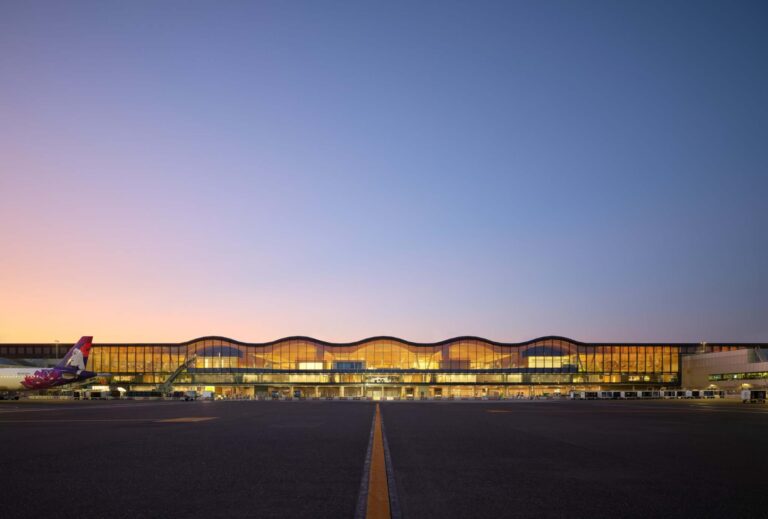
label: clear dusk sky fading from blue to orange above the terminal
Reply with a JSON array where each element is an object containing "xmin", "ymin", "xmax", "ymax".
[{"xmin": 0, "ymin": 0, "xmax": 768, "ymax": 343}]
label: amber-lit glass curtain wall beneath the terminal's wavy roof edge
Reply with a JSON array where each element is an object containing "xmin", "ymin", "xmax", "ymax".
[{"xmin": 89, "ymin": 338, "xmax": 752, "ymax": 384}]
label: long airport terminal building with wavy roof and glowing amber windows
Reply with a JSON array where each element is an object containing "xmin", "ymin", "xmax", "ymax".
[{"xmin": 0, "ymin": 336, "xmax": 768, "ymax": 399}]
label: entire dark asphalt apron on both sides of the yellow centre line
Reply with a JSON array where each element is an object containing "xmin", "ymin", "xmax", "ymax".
[{"xmin": 0, "ymin": 401, "xmax": 768, "ymax": 518}]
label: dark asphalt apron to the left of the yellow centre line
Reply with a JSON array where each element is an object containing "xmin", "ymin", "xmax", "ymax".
[{"xmin": 0, "ymin": 402, "xmax": 374, "ymax": 519}]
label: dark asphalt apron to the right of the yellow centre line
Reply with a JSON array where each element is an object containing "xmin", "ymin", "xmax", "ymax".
[{"xmin": 382, "ymin": 401, "xmax": 768, "ymax": 519}]
